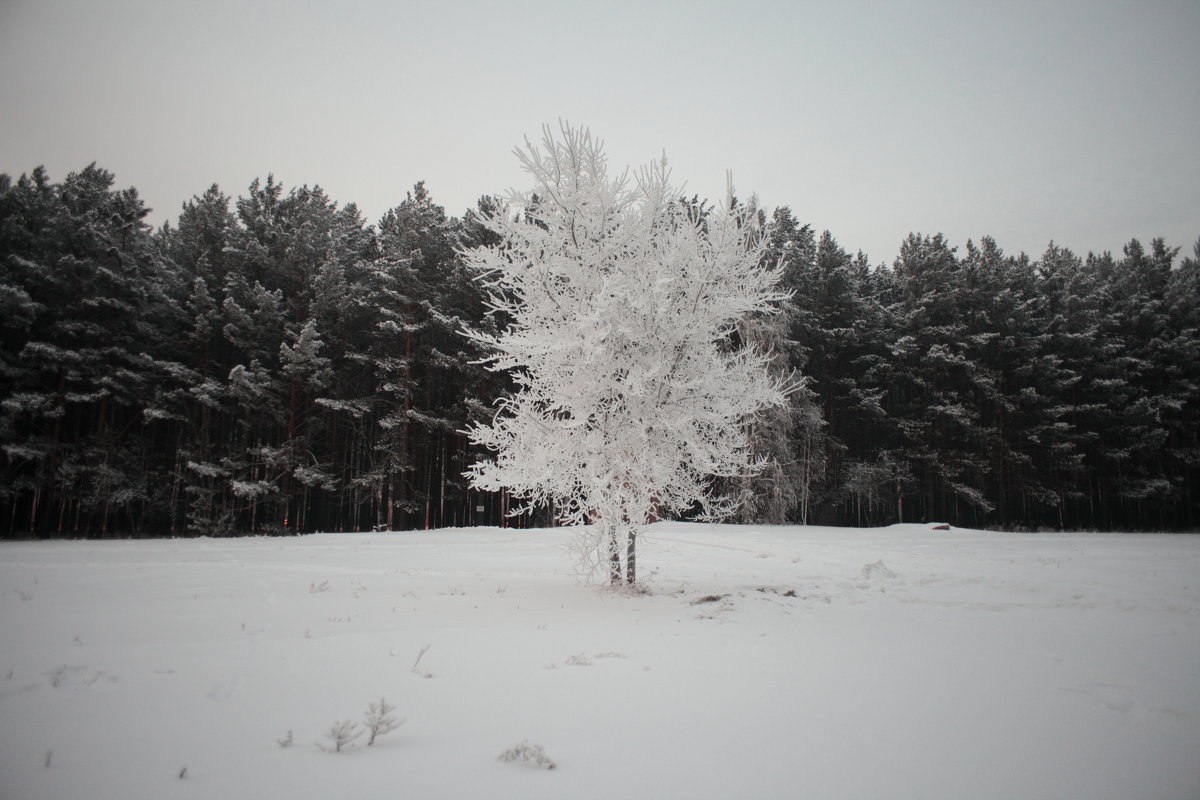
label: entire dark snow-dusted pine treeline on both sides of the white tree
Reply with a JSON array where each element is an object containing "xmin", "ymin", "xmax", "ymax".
[{"xmin": 0, "ymin": 166, "xmax": 1200, "ymax": 536}]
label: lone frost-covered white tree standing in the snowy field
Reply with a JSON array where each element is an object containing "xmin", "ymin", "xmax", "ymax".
[{"xmin": 466, "ymin": 124, "xmax": 791, "ymax": 583}]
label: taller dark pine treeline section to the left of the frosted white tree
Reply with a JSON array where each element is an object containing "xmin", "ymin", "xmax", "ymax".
[{"xmin": 0, "ymin": 166, "xmax": 504, "ymax": 535}]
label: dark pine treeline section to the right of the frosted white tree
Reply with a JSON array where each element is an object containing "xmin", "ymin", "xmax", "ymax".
[{"xmin": 748, "ymin": 207, "xmax": 1200, "ymax": 530}]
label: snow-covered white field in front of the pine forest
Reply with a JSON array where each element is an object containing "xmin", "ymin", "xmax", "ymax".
[{"xmin": 0, "ymin": 523, "xmax": 1200, "ymax": 800}]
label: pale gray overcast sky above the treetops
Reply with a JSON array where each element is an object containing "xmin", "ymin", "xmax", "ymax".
[{"xmin": 0, "ymin": 0, "xmax": 1200, "ymax": 263}]
